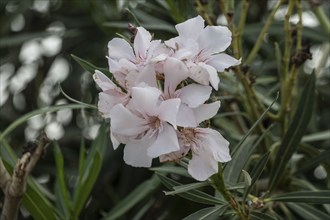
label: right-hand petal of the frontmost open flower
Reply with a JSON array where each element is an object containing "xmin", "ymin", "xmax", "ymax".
[{"xmin": 157, "ymin": 99, "xmax": 181, "ymax": 127}]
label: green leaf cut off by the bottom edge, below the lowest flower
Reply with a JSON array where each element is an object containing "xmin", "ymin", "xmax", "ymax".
[{"xmin": 183, "ymin": 205, "xmax": 228, "ymax": 220}]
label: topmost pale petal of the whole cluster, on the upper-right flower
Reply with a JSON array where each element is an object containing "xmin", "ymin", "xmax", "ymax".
[{"xmin": 175, "ymin": 15, "xmax": 204, "ymax": 39}]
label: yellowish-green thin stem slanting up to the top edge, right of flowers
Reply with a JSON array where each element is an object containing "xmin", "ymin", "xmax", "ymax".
[{"xmin": 246, "ymin": 0, "xmax": 283, "ymax": 65}]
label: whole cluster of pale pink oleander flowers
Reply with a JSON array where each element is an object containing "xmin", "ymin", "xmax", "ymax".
[{"xmin": 93, "ymin": 16, "xmax": 240, "ymax": 181}]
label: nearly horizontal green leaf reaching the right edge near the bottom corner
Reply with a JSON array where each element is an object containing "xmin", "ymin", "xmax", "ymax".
[{"xmin": 269, "ymin": 190, "xmax": 330, "ymax": 204}]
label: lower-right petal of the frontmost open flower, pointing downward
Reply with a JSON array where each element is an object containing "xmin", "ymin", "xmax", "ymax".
[{"xmin": 147, "ymin": 122, "xmax": 180, "ymax": 158}]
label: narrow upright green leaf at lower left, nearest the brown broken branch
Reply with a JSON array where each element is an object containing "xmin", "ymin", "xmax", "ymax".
[{"xmin": 54, "ymin": 142, "xmax": 71, "ymax": 218}]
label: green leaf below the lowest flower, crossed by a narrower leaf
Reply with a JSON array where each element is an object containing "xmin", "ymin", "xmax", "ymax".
[{"xmin": 156, "ymin": 173, "xmax": 226, "ymax": 205}]
